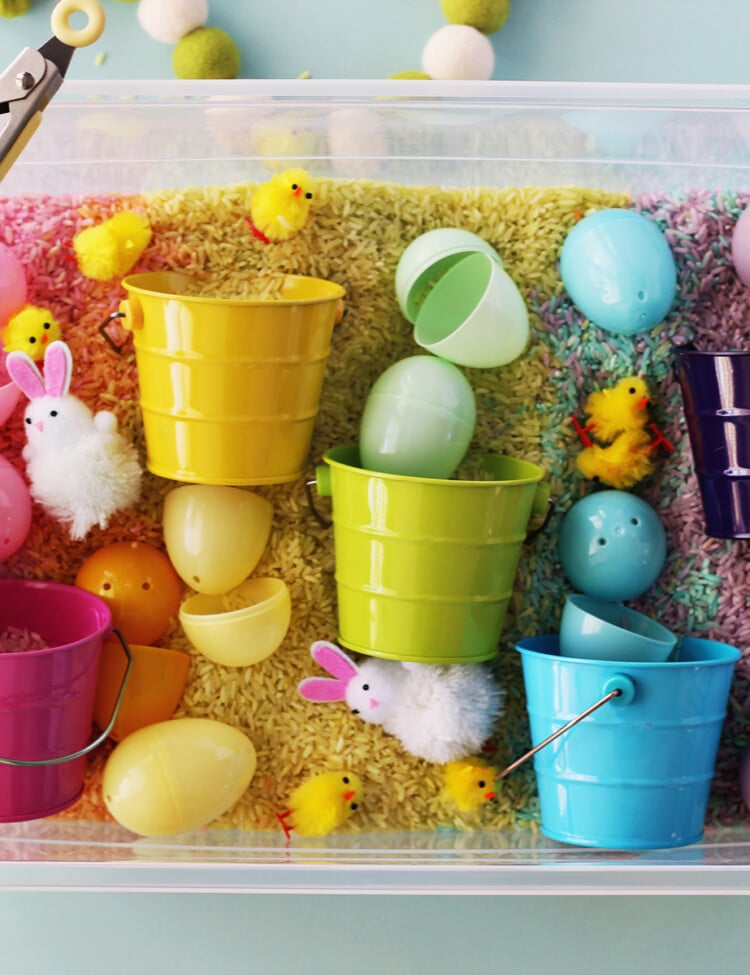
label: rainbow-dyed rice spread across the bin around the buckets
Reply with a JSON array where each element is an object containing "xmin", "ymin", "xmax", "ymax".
[{"xmin": 0, "ymin": 180, "xmax": 750, "ymax": 831}]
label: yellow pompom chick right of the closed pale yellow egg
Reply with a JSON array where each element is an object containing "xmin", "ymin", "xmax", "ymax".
[{"xmin": 278, "ymin": 771, "xmax": 363, "ymax": 836}]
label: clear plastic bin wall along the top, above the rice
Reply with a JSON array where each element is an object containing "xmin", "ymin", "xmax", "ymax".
[{"xmin": 0, "ymin": 80, "xmax": 750, "ymax": 195}]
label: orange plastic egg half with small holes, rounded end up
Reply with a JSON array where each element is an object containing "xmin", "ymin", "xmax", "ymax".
[{"xmin": 75, "ymin": 542, "xmax": 183, "ymax": 646}]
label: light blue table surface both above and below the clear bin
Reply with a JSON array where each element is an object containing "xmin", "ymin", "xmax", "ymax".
[{"xmin": 0, "ymin": 0, "xmax": 750, "ymax": 975}]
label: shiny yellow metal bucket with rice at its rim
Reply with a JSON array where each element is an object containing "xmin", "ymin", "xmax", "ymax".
[{"xmin": 120, "ymin": 271, "xmax": 344, "ymax": 484}]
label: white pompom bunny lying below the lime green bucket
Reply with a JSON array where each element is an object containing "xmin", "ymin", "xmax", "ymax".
[{"xmin": 298, "ymin": 640, "xmax": 503, "ymax": 764}]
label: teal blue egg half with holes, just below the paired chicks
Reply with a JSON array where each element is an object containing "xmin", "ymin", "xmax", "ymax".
[{"xmin": 558, "ymin": 491, "xmax": 667, "ymax": 602}]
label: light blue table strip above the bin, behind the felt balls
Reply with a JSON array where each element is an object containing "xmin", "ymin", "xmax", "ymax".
[{"xmin": 0, "ymin": 0, "xmax": 750, "ymax": 84}]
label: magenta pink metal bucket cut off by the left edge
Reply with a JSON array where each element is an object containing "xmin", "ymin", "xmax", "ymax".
[{"xmin": 0, "ymin": 579, "xmax": 132, "ymax": 823}]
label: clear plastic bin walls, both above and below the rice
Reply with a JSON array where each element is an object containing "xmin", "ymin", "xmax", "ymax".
[{"xmin": 0, "ymin": 80, "xmax": 750, "ymax": 893}]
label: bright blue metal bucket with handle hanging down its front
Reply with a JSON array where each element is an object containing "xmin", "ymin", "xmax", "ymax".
[{"xmin": 516, "ymin": 634, "xmax": 741, "ymax": 850}]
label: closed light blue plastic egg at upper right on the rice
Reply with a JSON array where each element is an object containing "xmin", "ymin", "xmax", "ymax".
[{"xmin": 560, "ymin": 210, "xmax": 677, "ymax": 335}]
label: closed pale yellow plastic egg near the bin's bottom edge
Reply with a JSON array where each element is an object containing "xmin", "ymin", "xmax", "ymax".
[{"xmin": 102, "ymin": 718, "xmax": 256, "ymax": 836}]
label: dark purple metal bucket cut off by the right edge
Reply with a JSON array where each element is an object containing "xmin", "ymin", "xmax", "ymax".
[{"xmin": 673, "ymin": 346, "xmax": 750, "ymax": 538}]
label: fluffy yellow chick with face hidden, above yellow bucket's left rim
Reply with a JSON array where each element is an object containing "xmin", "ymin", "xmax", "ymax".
[{"xmin": 73, "ymin": 210, "xmax": 152, "ymax": 281}]
